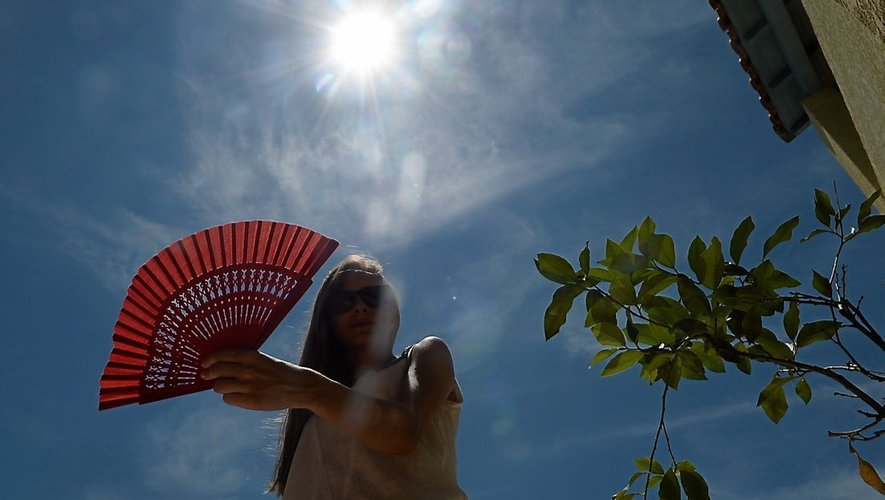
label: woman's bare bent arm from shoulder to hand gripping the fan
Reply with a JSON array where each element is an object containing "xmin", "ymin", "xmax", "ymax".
[{"xmin": 203, "ymin": 337, "xmax": 455, "ymax": 454}]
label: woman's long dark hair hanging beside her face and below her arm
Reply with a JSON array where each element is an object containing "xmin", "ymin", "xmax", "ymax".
[{"xmin": 267, "ymin": 255, "xmax": 399, "ymax": 496}]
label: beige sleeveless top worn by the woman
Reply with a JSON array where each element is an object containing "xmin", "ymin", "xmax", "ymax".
[{"xmin": 283, "ymin": 348, "xmax": 467, "ymax": 500}]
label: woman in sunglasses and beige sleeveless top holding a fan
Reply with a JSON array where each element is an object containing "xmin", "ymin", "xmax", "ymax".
[{"xmin": 201, "ymin": 255, "xmax": 466, "ymax": 499}]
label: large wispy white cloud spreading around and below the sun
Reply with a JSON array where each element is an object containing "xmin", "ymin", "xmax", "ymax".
[{"xmin": 167, "ymin": 2, "xmax": 704, "ymax": 254}]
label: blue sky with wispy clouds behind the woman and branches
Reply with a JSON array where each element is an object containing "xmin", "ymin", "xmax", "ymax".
[{"xmin": 0, "ymin": 0, "xmax": 885, "ymax": 500}]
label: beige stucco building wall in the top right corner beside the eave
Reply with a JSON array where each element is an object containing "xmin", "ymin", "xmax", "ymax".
[{"xmin": 802, "ymin": 0, "xmax": 885, "ymax": 212}]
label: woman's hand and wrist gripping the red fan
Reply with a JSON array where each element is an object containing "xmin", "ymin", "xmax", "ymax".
[{"xmin": 200, "ymin": 349, "xmax": 324, "ymax": 410}]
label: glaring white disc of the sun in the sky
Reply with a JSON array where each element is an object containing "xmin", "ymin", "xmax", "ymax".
[{"xmin": 332, "ymin": 11, "xmax": 396, "ymax": 74}]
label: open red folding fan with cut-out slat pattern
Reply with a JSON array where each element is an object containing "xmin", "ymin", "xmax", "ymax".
[{"xmin": 98, "ymin": 221, "xmax": 338, "ymax": 410}]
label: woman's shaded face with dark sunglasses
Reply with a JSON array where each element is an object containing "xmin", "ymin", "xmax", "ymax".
[{"xmin": 329, "ymin": 272, "xmax": 397, "ymax": 353}]
